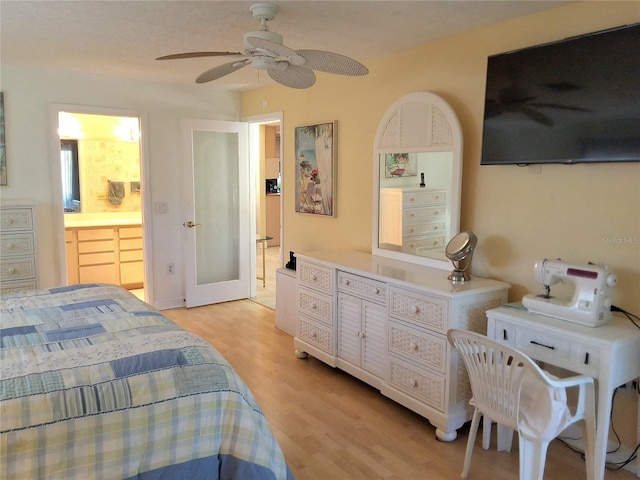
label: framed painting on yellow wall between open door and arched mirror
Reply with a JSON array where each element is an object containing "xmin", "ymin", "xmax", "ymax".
[{"xmin": 295, "ymin": 121, "xmax": 338, "ymax": 217}]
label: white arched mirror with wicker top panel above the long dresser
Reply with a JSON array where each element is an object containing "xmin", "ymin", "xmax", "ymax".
[{"xmin": 372, "ymin": 92, "xmax": 462, "ymax": 270}]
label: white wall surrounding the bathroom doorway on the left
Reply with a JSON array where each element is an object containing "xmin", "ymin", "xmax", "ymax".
[{"xmin": 0, "ymin": 64, "xmax": 240, "ymax": 308}]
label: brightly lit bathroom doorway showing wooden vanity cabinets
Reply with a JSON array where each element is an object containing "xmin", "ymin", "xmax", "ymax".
[{"xmin": 58, "ymin": 109, "xmax": 145, "ymax": 300}]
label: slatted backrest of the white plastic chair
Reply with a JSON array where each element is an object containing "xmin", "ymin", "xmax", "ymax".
[{"xmin": 447, "ymin": 329, "xmax": 544, "ymax": 430}]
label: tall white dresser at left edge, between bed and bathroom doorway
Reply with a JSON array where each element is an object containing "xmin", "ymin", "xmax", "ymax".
[{"xmin": 0, "ymin": 202, "xmax": 38, "ymax": 293}]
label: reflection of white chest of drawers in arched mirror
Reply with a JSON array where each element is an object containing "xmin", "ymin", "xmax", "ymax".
[{"xmin": 380, "ymin": 188, "xmax": 450, "ymax": 255}]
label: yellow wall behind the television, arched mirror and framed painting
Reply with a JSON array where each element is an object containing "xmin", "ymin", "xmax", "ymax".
[{"xmin": 242, "ymin": 1, "xmax": 640, "ymax": 314}]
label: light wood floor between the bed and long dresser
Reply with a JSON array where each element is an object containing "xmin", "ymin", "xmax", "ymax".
[{"xmin": 163, "ymin": 300, "xmax": 636, "ymax": 480}]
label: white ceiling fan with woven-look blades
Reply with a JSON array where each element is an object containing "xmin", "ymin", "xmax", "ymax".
[{"xmin": 156, "ymin": 2, "xmax": 369, "ymax": 88}]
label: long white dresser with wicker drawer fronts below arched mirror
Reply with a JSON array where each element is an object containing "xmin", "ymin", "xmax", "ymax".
[{"xmin": 294, "ymin": 251, "xmax": 510, "ymax": 441}]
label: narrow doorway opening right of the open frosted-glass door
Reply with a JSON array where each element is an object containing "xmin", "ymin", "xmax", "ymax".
[{"xmin": 245, "ymin": 113, "xmax": 284, "ymax": 310}]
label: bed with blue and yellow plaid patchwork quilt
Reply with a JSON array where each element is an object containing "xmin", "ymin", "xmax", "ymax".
[{"xmin": 0, "ymin": 284, "xmax": 293, "ymax": 480}]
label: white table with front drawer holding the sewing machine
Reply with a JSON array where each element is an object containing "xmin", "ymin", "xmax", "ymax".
[{"xmin": 487, "ymin": 304, "xmax": 640, "ymax": 480}]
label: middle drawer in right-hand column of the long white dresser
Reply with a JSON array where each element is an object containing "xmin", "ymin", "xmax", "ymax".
[{"xmin": 389, "ymin": 322, "xmax": 448, "ymax": 374}]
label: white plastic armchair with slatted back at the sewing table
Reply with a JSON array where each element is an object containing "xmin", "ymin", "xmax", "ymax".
[{"xmin": 447, "ymin": 329, "xmax": 595, "ymax": 480}]
